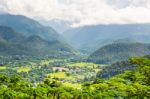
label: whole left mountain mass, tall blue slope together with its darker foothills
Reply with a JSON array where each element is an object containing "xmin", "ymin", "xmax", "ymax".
[{"xmin": 0, "ymin": 14, "xmax": 74, "ymax": 56}]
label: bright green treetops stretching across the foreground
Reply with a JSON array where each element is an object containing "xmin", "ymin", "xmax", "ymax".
[{"xmin": 0, "ymin": 58, "xmax": 150, "ymax": 99}]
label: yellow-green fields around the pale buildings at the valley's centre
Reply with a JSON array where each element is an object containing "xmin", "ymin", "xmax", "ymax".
[{"xmin": 48, "ymin": 62, "xmax": 101, "ymax": 82}]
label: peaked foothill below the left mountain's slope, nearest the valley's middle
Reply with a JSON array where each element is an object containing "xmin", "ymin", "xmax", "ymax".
[{"xmin": 22, "ymin": 35, "xmax": 72, "ymax": 56}]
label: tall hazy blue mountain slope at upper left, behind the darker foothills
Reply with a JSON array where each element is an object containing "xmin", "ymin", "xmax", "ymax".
[{"xmin": 0, "ymin": 14, "xmax": 67, "ymax": 42}]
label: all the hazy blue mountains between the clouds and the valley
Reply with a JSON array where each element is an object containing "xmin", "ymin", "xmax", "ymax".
[{"xmin": 0, "ymin": 14, "xmax": 150, "ymax": 63}]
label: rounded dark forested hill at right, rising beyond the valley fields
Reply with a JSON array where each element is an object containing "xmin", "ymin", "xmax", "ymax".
[{"xmin": 88, "ymin": 43, "xmax": 150, "ymax": 64}]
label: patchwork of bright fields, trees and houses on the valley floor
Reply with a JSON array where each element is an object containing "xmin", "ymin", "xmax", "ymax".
[{"xmin": 0, "ymin": 58, "xmax": 103, "ymax": 85}]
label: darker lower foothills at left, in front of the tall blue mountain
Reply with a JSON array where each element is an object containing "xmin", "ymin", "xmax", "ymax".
[{"xmin": 0, "ymin": 26, "xmax": 72, "ymax": 56}]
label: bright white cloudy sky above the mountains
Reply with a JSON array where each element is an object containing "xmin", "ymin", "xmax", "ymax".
[{"xmin": 0, "ymin": 0, "xmax": 150, "ymax": 27}]
